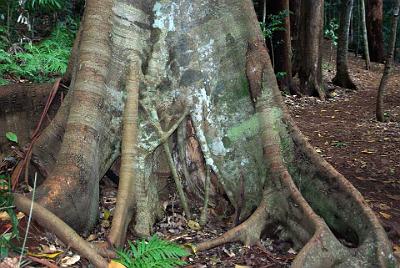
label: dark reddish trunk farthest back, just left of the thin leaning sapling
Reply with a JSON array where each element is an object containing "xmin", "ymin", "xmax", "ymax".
[{"xmin": 366, "ymin": 0, "xmax": 385, "ymax": 63}]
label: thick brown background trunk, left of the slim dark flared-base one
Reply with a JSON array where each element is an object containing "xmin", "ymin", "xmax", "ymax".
[{"xmin": 298, "ymin": 0, "xmax": 325, "ymax": 99}]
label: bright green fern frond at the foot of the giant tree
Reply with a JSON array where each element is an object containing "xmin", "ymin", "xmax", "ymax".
[{"xmin": 116, "ymin": 236, "xmax": 189, "ymax": 268}]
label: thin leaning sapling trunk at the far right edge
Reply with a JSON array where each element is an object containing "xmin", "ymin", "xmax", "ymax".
[{"xmin": 376, "ymin": 0, "xmax": 400, "ymax": 122}]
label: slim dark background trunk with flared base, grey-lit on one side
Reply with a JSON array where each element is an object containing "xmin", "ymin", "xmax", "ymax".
[{"xmin": 333, "ymin": 0, "xmax": 356, "ymax": 89}]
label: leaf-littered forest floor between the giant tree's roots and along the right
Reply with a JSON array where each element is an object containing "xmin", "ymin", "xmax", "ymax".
[{"xmin": 0, "ymin": 43, "xmax": 400, "ymax": 268}]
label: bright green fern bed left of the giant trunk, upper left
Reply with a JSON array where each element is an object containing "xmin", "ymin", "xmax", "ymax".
[{"xmin": 0, "ymin": 20, "xmax": 78, "ymax": 85}]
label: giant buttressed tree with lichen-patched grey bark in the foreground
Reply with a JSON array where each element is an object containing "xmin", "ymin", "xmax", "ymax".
[{"xmin": 1, "ymin": 0, "xmax": 395, "ymax": 267}]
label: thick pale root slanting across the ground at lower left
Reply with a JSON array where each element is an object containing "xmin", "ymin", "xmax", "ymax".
[{"xmin": 13, "ymin": 194, "xmax": 108, "ymax": 268}]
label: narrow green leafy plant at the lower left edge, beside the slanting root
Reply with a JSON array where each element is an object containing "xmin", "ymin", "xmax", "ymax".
[{"xmin": 0, "ymin": 174, "xmax": 18, "ymax": 259}]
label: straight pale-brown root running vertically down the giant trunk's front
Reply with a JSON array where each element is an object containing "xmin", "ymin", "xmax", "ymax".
[{"xmin": 108, "ymin": 56, "xmax": 140, "ymax": 247}]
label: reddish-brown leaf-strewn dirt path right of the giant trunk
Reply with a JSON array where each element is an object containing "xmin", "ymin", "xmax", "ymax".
[{"xmin": 286, "ymin": 49, "xmax": 400, "ymax": 254}]
